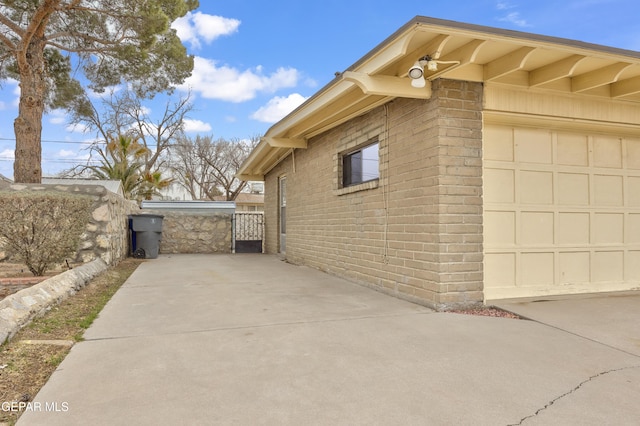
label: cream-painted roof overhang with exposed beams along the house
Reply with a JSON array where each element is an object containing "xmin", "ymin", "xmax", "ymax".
[{"xmin": 239, "ymin": 17, "xmax": 640, "ymax": 178}]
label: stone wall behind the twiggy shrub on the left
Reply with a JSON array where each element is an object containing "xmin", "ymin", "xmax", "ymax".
[{"xmin": 0, "ymin": 184, "xmax": 138, "ymax": 265}]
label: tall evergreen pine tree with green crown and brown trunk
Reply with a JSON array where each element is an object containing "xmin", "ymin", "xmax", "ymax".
[{"xmin": 0, "ymin": 0, "xmax": 198, "ymax": 183}]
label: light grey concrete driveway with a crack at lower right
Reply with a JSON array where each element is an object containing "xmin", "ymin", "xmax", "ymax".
[{"xmin": 18, "ymin": 255, "xmax": 640, "ymax": 426}]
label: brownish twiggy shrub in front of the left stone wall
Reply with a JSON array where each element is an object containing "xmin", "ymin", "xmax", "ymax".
[{"xmin": 0, "ymin": 191, "xmax": 93, "ymax": 276}]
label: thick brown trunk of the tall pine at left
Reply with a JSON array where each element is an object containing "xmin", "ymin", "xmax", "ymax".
[{"xmin": 13, "ymin": 37, "xmax": 46, "ymax": 183}]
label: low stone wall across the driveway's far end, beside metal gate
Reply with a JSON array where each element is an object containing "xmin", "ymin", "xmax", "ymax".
[{"xmin": 142, "ymin": 209, "xmax": 232, "ymax": 254}]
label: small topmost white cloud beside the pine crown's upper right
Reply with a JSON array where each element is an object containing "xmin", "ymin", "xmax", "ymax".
[{"xmin": 171, "ymin": 12, "xmax": 240, "ymax": 48}]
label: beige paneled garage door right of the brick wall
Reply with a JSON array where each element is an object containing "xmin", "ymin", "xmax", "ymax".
[{"xmin": 484, "ymin": 125, "xmax": 640, "ymax": 300}]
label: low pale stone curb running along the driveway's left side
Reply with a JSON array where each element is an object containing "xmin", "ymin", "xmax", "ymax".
[{"xmin": 0, "ymin": 259, "xmax": 108, "ymax": 343}]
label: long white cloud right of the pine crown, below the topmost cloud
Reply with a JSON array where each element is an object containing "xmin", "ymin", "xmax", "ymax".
[{"xmin": 179, "ymin": 57, "xmax": 300, "ymax": 102}]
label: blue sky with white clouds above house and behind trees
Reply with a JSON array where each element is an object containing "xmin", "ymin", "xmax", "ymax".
[{"xmin": 0, "ymin": 0, "xmax": 640, "ymax": 177}]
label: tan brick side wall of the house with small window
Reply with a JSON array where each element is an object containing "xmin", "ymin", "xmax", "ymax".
[{"xmin": 265, "ymin": 80, "xmax": 483, "ymax": 309}]
